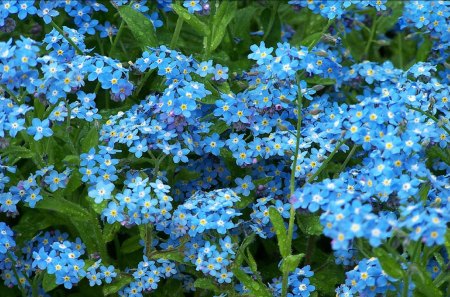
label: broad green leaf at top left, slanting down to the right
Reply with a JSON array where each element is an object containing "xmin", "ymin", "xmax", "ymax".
[{"xmin": 117, "ymin": 6, "xmax": 158, "ymax": 49}]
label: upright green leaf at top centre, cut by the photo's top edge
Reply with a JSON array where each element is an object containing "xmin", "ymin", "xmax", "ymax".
[{"xmin": 209, "ymin": 1, "xmax": 237, "ymax": 53}]
